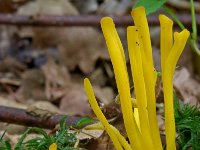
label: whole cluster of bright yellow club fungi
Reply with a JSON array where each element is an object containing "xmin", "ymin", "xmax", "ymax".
[{"xmin": 84, "ymin": 7, "xmax": 189, "ymax": 150}]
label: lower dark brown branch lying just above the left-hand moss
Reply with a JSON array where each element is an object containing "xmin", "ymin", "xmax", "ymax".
[{"xmin": 0, "ymin": 106, "xmax": 92, "ymax": 129}]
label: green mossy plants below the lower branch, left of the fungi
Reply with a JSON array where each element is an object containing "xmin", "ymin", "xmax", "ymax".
[{"xmin": 0, "ymin": 118, "xmax": 79, "ymax": 150}]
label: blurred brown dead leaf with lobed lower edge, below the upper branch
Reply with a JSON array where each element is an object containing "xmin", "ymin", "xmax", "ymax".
[{"xmin": 59, "ymin": 27, "xmax": 109, "ymax": 73}]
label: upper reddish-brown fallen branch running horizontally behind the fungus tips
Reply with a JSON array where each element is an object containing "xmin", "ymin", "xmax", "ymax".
[{"xmin": 0, "ymin": 14, "xmax": 200, "ymax": 27}]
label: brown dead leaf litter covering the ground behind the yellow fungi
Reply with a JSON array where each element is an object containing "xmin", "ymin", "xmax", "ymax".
[{"xmin": 0, "ymin": 0, "xmax": 200, "ymax": 150}]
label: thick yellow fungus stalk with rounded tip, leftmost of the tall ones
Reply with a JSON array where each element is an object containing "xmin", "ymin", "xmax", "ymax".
[{"xmin": 101, "ymin": 17, "xmax": 142, "ymax": 149}]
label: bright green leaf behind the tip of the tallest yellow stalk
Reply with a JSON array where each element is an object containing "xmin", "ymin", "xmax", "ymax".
[{"xmin": 133, "ymin": 0, "xmax": 167, "ymax": 15}]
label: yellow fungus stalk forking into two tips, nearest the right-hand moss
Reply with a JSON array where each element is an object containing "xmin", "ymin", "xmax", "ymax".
[{"xmin": 159, "ymin": 15, "xmax": 190, "ymax": 150}]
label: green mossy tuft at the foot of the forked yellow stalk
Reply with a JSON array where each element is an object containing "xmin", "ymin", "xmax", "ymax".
[{"xmin": 174, "ymin": 95, "xmax": 200, "ymax": 150}]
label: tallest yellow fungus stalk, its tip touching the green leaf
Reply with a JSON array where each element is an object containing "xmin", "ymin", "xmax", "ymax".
[{"xmin": 130, "ymin": 7, "xmax": 162, "ymax": 149}]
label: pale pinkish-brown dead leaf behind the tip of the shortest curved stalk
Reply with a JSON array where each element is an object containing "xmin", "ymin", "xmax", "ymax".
[{"xmin": 60, "ymin": 84, "xmax": 114, "ymax": 116}]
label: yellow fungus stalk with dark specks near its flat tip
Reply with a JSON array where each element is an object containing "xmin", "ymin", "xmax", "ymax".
[{"xmin": 127, "ymin": 26, "xmax": 155, "ymax": 149}]
